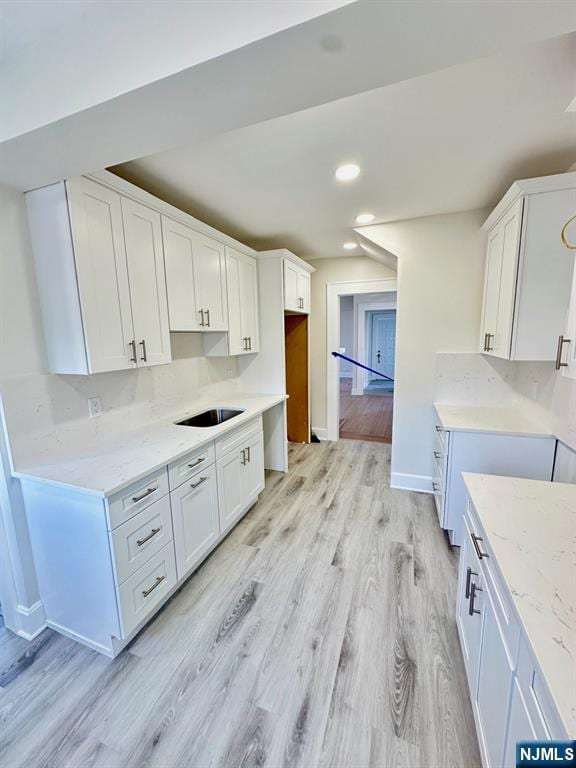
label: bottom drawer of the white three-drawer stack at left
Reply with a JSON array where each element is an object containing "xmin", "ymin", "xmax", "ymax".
[{"xmin": 116, "ymin": 542, "xmax": 176, "ymax": 638}]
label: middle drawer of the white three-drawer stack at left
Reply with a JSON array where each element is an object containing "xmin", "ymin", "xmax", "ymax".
[{"xmin": 110, "ymin": 496, "xmax": 173, "ymax": 585}]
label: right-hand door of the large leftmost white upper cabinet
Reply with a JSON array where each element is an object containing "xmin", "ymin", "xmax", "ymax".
[{"xmin": 122, "ymin": 197, "xmax": 172, "ymax": 366}]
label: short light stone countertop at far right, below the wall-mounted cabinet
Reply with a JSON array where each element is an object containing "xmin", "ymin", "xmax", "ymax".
[{"xmin": 434, "ymin": 403, "xmax": 554, "ymax": 437}]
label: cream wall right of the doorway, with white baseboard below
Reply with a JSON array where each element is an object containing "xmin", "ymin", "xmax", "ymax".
[{"xmin": 360, "ymin": 210, "xmax": 487, "ymax": 489}]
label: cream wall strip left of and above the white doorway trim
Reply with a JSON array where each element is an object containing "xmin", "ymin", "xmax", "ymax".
[{"xmin": 310, "ymin": 256, "xmax": 396, "ymax": 430}]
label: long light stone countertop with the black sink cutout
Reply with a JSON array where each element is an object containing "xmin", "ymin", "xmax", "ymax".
[{"xmin": 12, "ymin": 394, "xmax": 287, "ymax": 497}]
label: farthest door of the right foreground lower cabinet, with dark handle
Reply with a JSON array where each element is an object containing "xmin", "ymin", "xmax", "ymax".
[{"xmin": 456, "ymin": 518, "xmax": 484, "ymax": 700}]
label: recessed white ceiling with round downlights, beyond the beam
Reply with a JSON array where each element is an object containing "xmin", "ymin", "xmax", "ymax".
[{"xmin": 116, "ymin": 33, "xmax": 576, "ymax": 259}]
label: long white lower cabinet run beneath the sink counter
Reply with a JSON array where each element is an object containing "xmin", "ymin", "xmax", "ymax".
[{"xmin": 22, "ymin": 416, "xmax": 264, "ymax": 656}]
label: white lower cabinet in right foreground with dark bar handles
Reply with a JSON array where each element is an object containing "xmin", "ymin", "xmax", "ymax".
[{"xmin": 456, "ymin": 501, "xmax": 567, "ymax": 768}]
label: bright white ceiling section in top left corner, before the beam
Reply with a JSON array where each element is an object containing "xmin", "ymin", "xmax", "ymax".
[{"xmin": 0, "ymin": 0, "xmax": 351, "ymax": 139}]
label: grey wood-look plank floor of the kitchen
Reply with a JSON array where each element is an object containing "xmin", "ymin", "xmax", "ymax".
[{"xmin": 0, "ymin": 440, "xmax": 480, "ymax": 768}]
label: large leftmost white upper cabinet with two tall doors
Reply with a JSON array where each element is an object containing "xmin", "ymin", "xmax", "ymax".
[{"xmin": 26, "ymin": 178, "xmax": 171, "ymax": 374}]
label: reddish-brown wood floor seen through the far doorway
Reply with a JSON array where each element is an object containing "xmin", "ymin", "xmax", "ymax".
[{"xmin": 340, "ymin": 379, "xmax": 394, "ymax": 443}]
